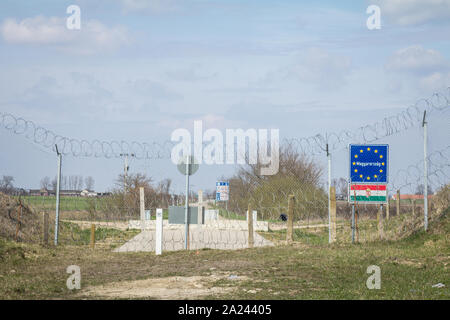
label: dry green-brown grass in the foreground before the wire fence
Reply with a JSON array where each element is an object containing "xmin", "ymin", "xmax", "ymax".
[{"xmin": 0, "ymin": 211, "xmax": 450, "ymax": 299}]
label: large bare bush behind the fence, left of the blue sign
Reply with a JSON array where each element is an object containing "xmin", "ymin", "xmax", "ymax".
[{"xmin": 224, "ymin": 144, "xmax": 327, "ymax": 218}]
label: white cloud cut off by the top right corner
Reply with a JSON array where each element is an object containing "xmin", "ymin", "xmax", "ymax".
[{"xmin": 369, "ymin": 0, "xmax": 450, "ymax": 25}]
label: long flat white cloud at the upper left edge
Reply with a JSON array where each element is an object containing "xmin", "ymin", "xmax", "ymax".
[{"xmin": 0, "ymin": 16, "xmax": 128, "ymax": 54}]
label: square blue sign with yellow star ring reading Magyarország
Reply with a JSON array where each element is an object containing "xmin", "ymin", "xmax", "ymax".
[{"xmin": 349, "ymin": 144, "xmax": 389, "ymax": 183}]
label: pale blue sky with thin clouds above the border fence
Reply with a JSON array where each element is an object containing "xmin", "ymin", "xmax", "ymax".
[{"xmin": 0, "ymin": 0, "xmax": 450, "ymax": 190}]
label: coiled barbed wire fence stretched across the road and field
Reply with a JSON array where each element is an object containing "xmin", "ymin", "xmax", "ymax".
[{"xmin": 0, "ymin": 88, "xmax": 450, "ymax": 251}]
